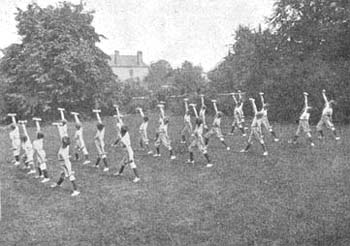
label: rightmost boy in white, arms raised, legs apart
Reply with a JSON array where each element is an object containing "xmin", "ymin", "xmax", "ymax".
[{"xmin": 316, "ymin": 90, "xmax": 340, "ymax": 140}]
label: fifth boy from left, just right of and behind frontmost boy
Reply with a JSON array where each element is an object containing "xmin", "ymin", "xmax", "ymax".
[{"xmin": 71, "ymin": 112, "xmax": 90, "ymax": 165}]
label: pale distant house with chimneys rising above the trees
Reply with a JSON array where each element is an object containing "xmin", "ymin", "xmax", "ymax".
[{"xmin": 109, "ymin": 50, "xmax": 149, "ymax": 81}]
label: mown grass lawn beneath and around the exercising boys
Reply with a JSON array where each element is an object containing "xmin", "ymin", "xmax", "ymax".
[{"xmin": 0, "ymin": 116, "xmax": 350, "ymax": 246}]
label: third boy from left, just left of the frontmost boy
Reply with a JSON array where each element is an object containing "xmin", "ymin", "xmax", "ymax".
[{"xmin": 33, "ymin": 118, "xmax": 50, "ymax": 183}]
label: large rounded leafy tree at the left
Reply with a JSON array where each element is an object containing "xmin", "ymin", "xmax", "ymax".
[{"xmin": 0, "ymin": 2, "xmax": 115, "ymax": 119}]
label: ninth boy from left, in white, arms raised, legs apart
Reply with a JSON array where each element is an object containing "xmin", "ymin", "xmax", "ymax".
[{"xmin": 153, "ymin": 104, "xmax": 176, "ymax": 160}]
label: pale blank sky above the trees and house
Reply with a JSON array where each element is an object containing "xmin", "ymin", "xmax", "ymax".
[{"xmin": 0, "ymin": 0, "xmax": 274, "ymax": 71}]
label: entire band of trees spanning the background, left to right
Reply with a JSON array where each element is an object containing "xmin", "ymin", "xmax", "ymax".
[{"xmin": 0, "ymin": 0, "xmax": 350, "ymax": 123}]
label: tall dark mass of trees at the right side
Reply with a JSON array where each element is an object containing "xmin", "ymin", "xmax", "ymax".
[{"xmin": 209, "ymin": 0, "xmax": 350, "ymax": 123}]
